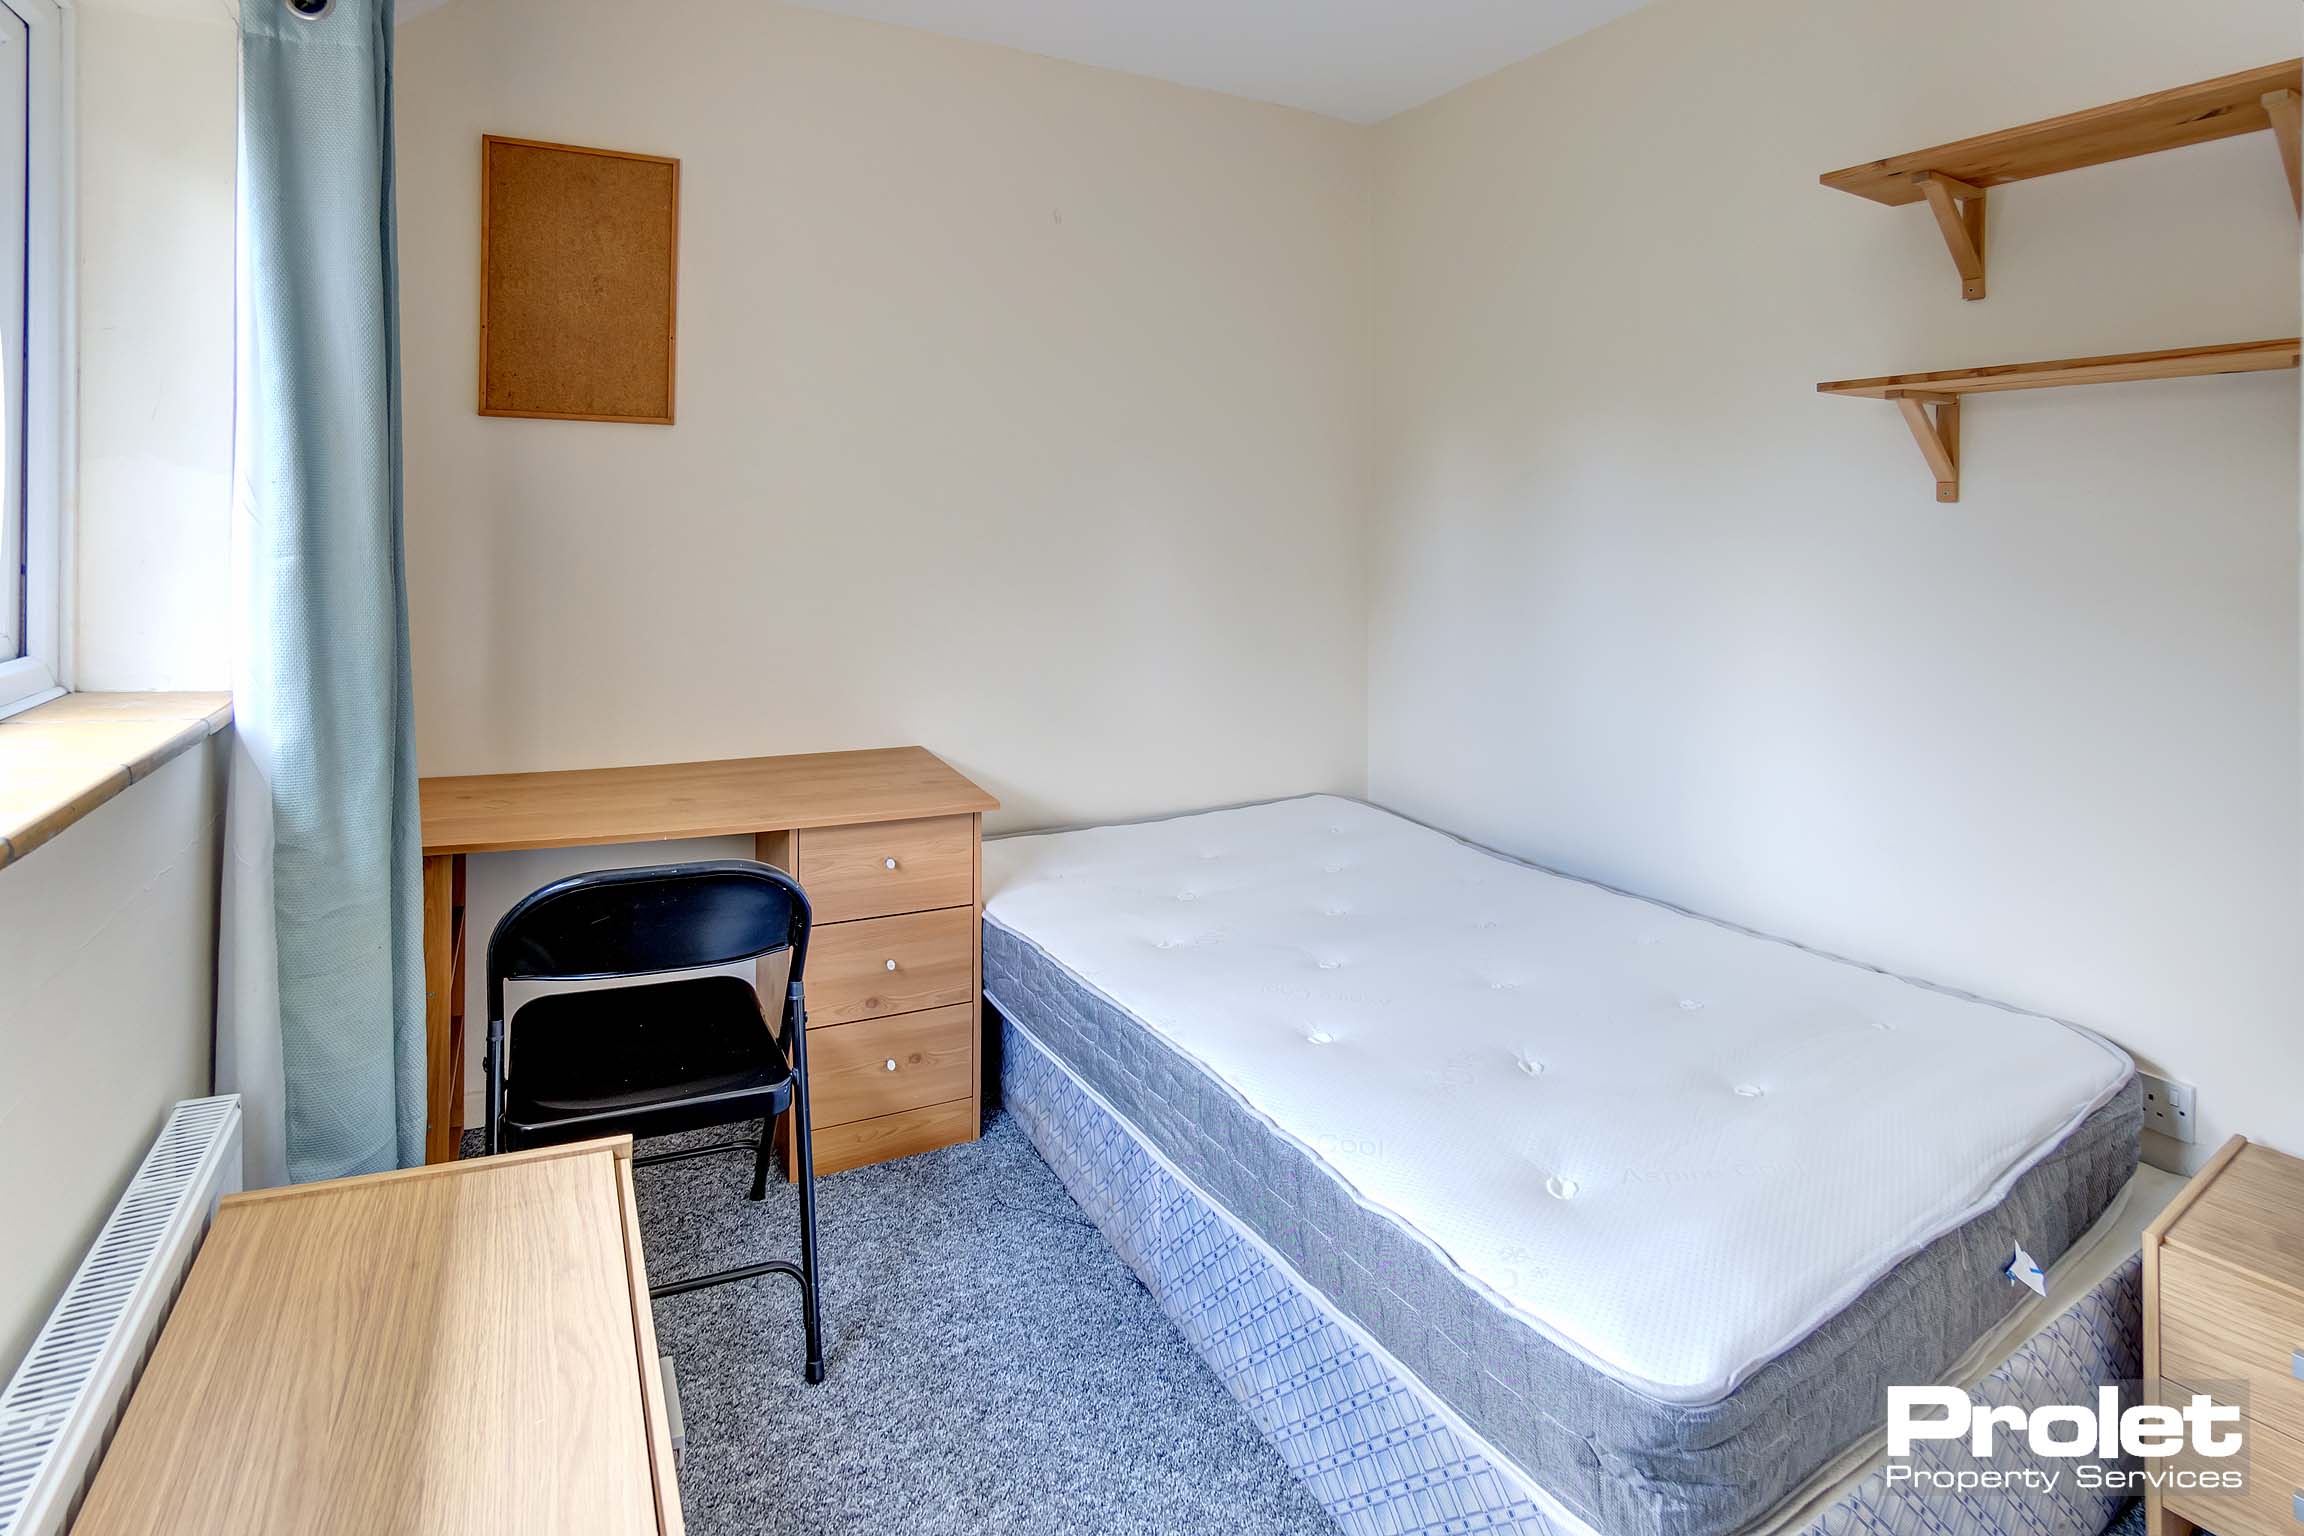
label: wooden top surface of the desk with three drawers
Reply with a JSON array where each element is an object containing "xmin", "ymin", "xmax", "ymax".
[{"xmin": 422, "ymin": 746, "xmax": 1000, "ymax": 854}]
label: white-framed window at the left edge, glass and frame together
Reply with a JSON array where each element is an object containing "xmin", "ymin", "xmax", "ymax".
[{"xmin": 0, "ymin": 0, "xmax": 65, "ymax": 712}]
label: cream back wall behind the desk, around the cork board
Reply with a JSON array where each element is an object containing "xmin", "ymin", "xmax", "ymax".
[{"xmin": 396, "ymin": 0, "xmax": 1373, "ymax": 827}]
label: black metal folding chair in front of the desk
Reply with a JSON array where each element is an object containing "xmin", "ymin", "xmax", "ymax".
[{"xmin": 488, "ymin": 859, "xmax": 825, "ymax": 1382}]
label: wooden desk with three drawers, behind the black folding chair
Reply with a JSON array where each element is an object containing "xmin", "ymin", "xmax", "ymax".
[{"xmin": 422, "ymin": 746, "xmax": 1000, "ymax": 1172}]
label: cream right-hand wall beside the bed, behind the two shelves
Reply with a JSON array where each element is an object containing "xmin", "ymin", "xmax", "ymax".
[{"xmin": 1369, "ymin": 0, "xmax": 2304, "ymax": 1163}]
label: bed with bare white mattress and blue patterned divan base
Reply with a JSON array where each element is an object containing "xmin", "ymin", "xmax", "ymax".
[{"xmin": 984, "ymin": 797, "xmax": 2140, "ymax": 1536}]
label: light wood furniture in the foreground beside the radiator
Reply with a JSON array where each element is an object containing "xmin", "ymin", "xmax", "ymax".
[{"xmin": 74, "ymin": 1138, "xmax": 682, "ymax": 1536}]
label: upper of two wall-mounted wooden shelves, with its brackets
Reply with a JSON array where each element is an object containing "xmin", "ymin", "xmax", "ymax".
[{"xmin": 1818, "ymin": 60, "xmax": 2304, "ymax": 299}]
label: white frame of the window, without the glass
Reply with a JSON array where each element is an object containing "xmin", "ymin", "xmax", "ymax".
[{"xmin": 0, "ymin": 0, "xmax": 71, "ymax": 716}]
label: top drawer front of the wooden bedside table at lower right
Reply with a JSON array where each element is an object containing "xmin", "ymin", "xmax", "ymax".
[{"xmin": 2157, "ymin": 1246, "xmax": 2304, "ymax": 1446}]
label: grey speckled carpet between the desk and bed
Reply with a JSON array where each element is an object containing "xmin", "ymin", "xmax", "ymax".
[{"xmin": 463, "ymin": 1115, "xmax": 1336, "ymax": 1536}]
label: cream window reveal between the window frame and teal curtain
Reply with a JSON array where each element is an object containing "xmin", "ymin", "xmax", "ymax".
[{"xmin": 71, "ymin": 0, "xmax": 240, "ymax": 691}]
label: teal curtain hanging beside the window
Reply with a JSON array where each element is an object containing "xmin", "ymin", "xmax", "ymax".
[{"xmin": 219, "ymin": 0, "xmax": 424, "ymax": 1181}]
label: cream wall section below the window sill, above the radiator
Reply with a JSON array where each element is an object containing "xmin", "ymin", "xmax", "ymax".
[{"xmin": 0, "ymin": 737, "xmax": 228, "ymax": 1379}]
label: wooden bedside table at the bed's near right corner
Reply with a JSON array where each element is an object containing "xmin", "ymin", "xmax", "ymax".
[{"xmin": 2143, "ymin": 1135, "xmax": 2304, "ymax": 1536}]
